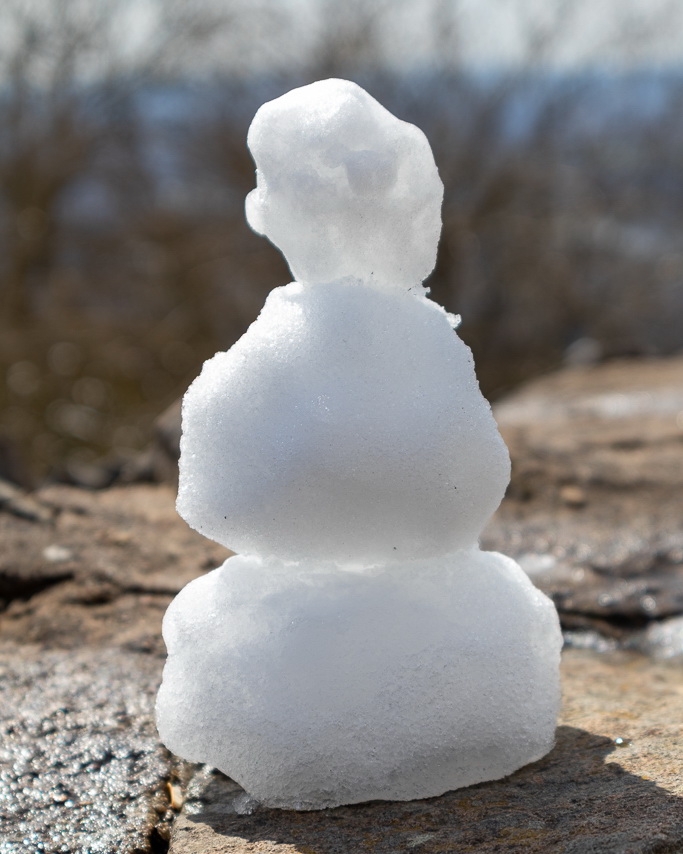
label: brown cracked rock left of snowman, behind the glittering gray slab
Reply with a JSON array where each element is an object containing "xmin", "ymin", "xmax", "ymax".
[{"xmin": 0, "ymin": 486, "xmax": 230, "ymax": 656}]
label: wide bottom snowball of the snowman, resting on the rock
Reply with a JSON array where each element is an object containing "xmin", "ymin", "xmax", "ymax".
[{"xmin": 157, "ymin": 549, "xmax": 562, "ymax": 809}]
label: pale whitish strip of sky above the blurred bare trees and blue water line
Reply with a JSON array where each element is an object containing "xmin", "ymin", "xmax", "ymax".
[{"xmin": 0, "ymin": 0, "xmax": 683, "ymax": 79}]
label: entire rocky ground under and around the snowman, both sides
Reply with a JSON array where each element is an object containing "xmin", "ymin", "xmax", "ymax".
[{"xmin": 0, "ymin": 359, "xmax": 683, "ymax": 854}]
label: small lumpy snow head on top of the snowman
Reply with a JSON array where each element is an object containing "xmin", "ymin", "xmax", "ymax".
[{"xmin": 246, "ymin": 79, "xmax": 443, "ymax": 289}]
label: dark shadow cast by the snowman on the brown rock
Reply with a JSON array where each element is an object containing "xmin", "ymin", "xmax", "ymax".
[{"xmin": 171, "ymin": 726, "xmax": 683, "ymax": 854}]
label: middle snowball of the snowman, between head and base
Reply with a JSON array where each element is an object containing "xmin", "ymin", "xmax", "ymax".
[{"xmin": 177, "ymin": 282, "xmax": 510, "ymax": 565}]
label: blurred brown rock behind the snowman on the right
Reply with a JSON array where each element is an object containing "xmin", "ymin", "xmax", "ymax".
[{"xmin": 483, "ymin": 358, "xmax": 683, "ymax": 649}]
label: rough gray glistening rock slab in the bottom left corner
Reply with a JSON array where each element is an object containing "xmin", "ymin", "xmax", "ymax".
[{"xmin": 0, "ymin": 644, "xmax": 172, "ymax": 854}]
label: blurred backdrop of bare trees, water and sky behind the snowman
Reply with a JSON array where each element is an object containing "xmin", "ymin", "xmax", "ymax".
[{"xmin": 0, "ymin": 0, "xmax": 683, "ymax": 487}]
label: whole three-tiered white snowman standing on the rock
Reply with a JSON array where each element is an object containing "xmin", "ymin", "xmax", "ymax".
[{"xmin": 157, "ymin": 80, "xmax": 561, "ymax": 809}]
